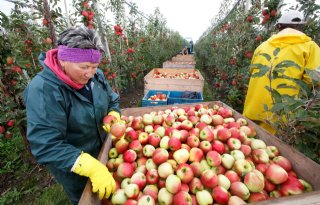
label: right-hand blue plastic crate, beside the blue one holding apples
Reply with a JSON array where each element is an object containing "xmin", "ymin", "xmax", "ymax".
[{"xmin": 168, "ymin": 91, "xmax": 203, "ymax": 105}]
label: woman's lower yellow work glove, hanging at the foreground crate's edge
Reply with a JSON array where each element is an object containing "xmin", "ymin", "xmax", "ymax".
[{"xmin": 73, "ymin": 153, "xmax": 116, "ymax": 200}]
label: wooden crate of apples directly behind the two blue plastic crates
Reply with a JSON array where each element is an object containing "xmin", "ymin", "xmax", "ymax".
[{"xmin": 144, "ymin": 68, "xmax": 204, "ymax": 94}]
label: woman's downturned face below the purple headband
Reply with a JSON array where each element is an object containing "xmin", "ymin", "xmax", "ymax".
[{"xmin": 60, "ymin": 61, "xmax": 99, "ymax": 85}]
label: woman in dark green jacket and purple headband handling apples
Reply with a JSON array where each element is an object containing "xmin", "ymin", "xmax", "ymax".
[{"xmin": 24, "ymin": 27, "xmax": 120, "ymax": 204}]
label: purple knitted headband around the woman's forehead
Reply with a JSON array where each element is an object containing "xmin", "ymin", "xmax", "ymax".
[{"xmin": 58, "ymin": 45, "xmax": 101, "ymax": 63}]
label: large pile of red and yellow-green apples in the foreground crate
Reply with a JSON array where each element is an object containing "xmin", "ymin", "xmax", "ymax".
[{"xmin": 104, "ymin": 104, "xmax": 312, "ymax": 205}]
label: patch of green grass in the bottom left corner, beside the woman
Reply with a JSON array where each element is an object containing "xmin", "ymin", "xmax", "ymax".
[{"xmin": 0, "ymin": 134, "xmax": 71, "ymax": 205}]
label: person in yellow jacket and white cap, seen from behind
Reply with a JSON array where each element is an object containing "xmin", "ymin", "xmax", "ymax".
[{"xmin": 243, "ymin": 10, "xmax": 320, "ymax": 134}]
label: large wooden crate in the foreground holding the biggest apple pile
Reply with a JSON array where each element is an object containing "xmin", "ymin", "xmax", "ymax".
[{"xmin": 79, "ymin": 101, "xmax": 320, "ymax": 205}]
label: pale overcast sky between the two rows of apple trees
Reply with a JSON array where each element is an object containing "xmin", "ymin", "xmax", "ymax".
[{"xmin": 132, "ymin": 0, "xmax": 223, "ymax": 42}]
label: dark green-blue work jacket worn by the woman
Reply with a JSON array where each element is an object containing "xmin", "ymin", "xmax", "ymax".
[{"xmin": 24, "ymin": 53, "xmax": 120, "ymax": 203}]
